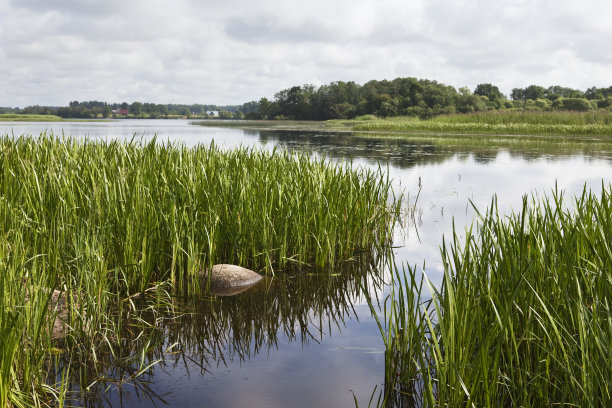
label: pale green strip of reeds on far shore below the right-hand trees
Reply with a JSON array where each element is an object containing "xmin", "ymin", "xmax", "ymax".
[{"xmin": 329, "ymin": 111, "xmax": 612, "ymax": 136}]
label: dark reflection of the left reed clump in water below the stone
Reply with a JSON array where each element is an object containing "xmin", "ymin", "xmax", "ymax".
[{"xmin": 50, "ymin": 254, "xmax": 383, "ymax": 407}]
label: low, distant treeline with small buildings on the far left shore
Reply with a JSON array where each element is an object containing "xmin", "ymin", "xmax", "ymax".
[{"xmin": 0, "ymin": 101, "xmax": 244, "ymax": 119}]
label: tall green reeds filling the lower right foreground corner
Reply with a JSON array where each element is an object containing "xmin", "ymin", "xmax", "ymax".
[{"xmin": 381, "ymin": 186, "xmax": 612, "ymax": 407}]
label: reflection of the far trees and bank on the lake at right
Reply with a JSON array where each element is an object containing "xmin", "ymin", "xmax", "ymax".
[{"xmin": 252, "ymin": 130, "xmax": 612, "ymax": 168}]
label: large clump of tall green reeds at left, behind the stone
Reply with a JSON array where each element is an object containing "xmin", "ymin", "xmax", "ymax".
[{"xmin": 0, "ymin": 136, "xmax": 398, "ymax": 406}]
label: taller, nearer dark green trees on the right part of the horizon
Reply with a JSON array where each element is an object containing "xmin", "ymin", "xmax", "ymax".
[{"xmin": 241, "ymin": 78, "xmax": 612, "ymax": 120}]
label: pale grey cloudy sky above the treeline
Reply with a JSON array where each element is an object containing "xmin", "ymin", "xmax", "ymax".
[{"xmin": 0, "ymin": 0, "xmax": 612, "ymax": 107}]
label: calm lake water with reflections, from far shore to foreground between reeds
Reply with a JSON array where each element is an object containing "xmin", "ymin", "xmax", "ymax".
[{"xmin": 0, "ymin": 121, "xmax": 612, "ymax": 407}]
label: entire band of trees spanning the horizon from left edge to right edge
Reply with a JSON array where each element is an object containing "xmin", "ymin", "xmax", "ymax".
[{"xmin": 0, "ymin": 78, "xmax": 612, "ymax": 120}]
